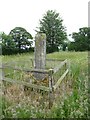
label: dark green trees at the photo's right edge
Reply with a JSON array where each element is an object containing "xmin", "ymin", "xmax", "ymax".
[{"xmin": 69, "ymin": 27, "xmax": 90, "ymax": 51}]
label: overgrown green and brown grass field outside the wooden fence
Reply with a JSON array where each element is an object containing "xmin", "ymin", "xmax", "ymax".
[{"xmin": 0, "ymin": 52, "xmax": 89, "ymax": 118}]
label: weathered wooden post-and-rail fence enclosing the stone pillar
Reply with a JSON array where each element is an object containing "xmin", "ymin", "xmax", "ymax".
[{"xmin": 0, "ymin": 59, "xmax": 69, "ymax": 108}]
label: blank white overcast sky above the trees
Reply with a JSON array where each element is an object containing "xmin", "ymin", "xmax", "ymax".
[{"xmin": 0, "ymin": 0, "xmax": 89, "ymax": 40}]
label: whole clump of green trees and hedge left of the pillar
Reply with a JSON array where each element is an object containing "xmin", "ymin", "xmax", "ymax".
[{"xmin": 0, "ymin": 27, "xmax": 34, "ymax": 55}]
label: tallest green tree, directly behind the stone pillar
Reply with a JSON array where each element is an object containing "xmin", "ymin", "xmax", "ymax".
[{"xmin": 37, "ymin": 10, "xmax": 67, "ymax": 52}]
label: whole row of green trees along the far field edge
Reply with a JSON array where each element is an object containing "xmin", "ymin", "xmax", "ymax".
[{"xmin": 0, "ymin": 10, "xmax": 90, "ymax": 55}]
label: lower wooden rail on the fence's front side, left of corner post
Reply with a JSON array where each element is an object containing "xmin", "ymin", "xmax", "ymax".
[{"xmin": 2, "ymin": 77, "xmax": 50, "ymax": 91}]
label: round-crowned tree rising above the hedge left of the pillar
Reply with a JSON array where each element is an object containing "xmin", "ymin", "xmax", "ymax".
[{"xmin": 9, "ymin": 27, "xmax": 33, "ymax": 52}]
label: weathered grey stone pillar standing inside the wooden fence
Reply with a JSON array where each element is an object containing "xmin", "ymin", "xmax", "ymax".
[{"xmin": 34, "ymin": 33, "xmax": 46, "ymax": 79}]
